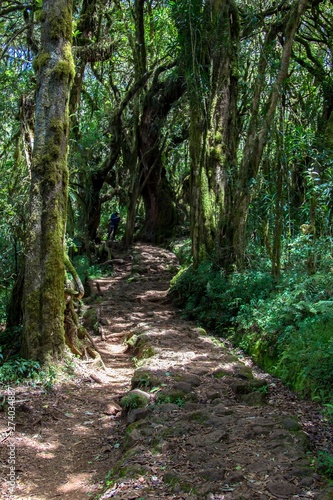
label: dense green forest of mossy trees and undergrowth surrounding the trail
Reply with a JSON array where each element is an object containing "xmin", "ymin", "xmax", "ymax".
[{"xmin": 0, "ymin": 0, "xmax": 333, "ymax": 416}]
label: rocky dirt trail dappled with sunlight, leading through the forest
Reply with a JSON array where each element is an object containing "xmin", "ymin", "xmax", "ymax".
[{"xmin": 0, "ymin": 244, "xmax": 333, "ymax": 500}]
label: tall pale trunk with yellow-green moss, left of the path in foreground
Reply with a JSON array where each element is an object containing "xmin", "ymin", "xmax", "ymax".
[{"xmin": 22, "ymin": 0, "xmax": 74, "ymax": 363}]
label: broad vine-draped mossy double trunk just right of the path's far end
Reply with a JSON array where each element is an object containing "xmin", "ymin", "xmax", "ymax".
[{"xmin": 179, "ymin": 0, "xmax": 239, "ymax": 266}]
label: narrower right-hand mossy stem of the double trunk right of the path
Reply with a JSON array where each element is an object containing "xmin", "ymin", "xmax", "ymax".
[{"xmin": 204, "ymin": 0, "xmax": 240, "ymax": 267}]
